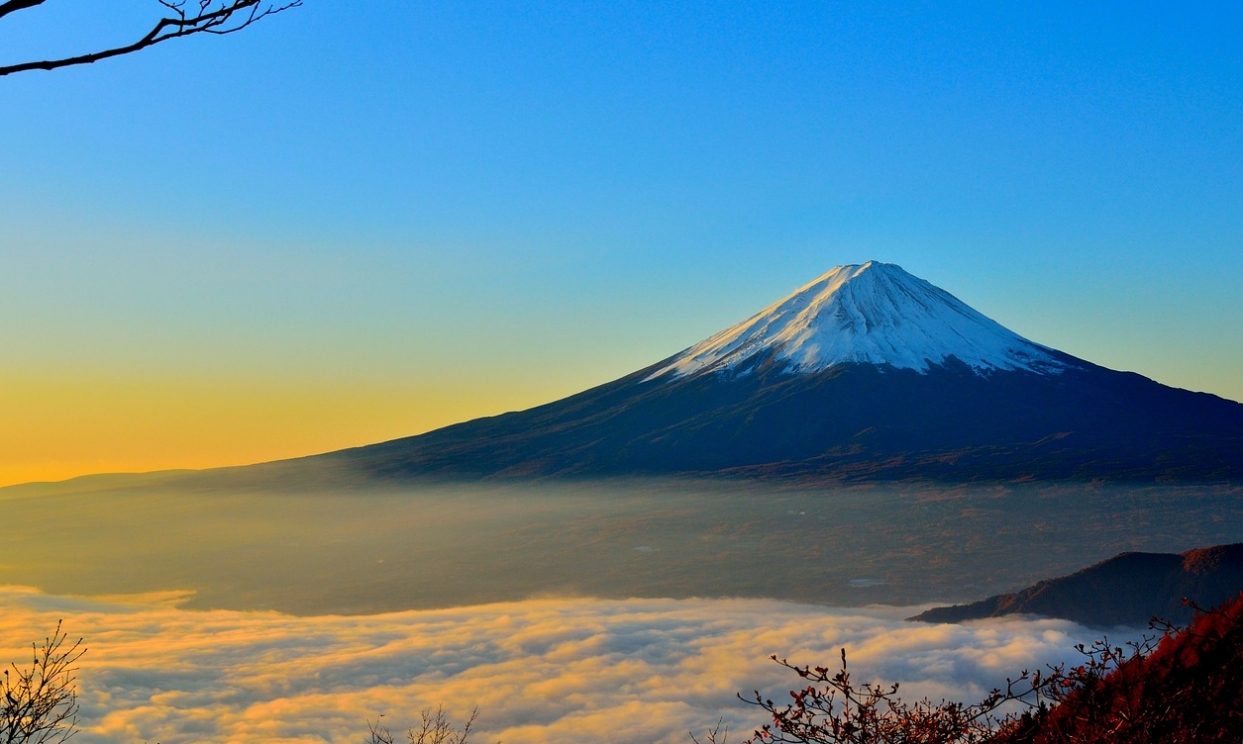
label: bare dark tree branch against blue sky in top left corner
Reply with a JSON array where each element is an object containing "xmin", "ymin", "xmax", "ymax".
[{"xmin": 0, "ymin": 0, "xmax": 302, "ymax": 77}]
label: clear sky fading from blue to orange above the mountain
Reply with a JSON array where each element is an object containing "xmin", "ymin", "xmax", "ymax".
[{"xmin": 0, "ymin": 0, "xmax": 1243, "ymax": 483}]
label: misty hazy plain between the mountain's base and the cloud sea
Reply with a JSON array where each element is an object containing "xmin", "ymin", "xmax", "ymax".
[{"xmin": 0, "ymin": 471, "xmax": 1243, "ymax": 615}]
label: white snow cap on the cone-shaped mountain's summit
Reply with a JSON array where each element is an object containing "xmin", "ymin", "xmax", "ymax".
[{"xmin": 648, "ymin": 261, "xmax": 1065, "ymax": 380}]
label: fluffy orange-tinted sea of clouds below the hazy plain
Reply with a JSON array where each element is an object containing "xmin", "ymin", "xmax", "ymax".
[{"xmin": 0, "ymin": 586, "xmax": 1113, "ymax": 744}]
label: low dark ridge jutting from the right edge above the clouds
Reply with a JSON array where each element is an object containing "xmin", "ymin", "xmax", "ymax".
[{"xmin": 911, "ymin": 543, "xmax": 1243, "ymax": 626}]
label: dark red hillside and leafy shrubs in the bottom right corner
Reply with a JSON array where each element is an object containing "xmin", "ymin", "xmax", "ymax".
[{"xmin": 747, "ymin": 595, "xmax": 1243, "ymax": 744}]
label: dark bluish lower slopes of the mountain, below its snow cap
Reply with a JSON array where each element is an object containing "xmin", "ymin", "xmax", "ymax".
[{"xmin": 321, "ymin": 355, "xmax": 1243, "ymax": 482}]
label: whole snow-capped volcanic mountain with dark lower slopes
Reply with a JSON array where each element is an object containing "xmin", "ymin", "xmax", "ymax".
[{"xmin": 317, "ymin": 262, "xmax": 1243, "ymax": 482}]
